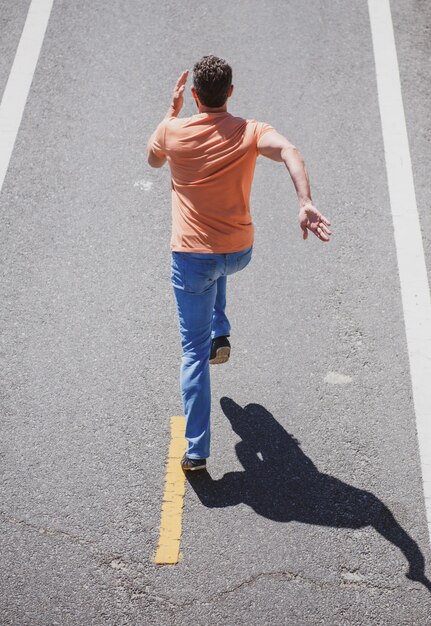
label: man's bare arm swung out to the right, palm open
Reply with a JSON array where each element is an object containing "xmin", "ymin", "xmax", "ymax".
[{"xmin": 257, "ymin": 130, "xmax": 331, "ymax": 241}]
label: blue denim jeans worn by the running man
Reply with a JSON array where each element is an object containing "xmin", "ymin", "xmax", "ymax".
[{"xmin": 171, "ymin": 246, "xmax": 253, "ymax": 459}]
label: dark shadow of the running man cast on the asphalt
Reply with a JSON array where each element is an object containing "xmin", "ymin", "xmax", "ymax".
[{"xmin": 186, "ymin": 397, "xmax": 431, "ymax": 591}]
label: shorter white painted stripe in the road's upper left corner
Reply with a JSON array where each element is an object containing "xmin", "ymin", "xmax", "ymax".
[{"xmin": 0, "ymin": 0, "xmax": 53, "ymax": 192}]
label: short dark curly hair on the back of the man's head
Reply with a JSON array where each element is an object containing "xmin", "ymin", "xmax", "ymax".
[{"xmin": 193, "ymin": 54, "xmax": 232, "ymax": 107}]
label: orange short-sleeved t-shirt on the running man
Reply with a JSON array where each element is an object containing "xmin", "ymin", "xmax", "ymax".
[{"xmin": 152, "ymin": 111, "xmax": 274, "ymax": 254}]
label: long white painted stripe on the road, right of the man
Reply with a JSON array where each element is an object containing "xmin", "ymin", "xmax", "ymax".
[{"xmin": 368, "ymin": 0, "xmax": 431, "ymax": 538}]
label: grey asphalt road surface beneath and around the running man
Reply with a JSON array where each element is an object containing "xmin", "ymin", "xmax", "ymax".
[{"xmin": 0, "ymin": 0, "xmax": 431, "ymax": 626}]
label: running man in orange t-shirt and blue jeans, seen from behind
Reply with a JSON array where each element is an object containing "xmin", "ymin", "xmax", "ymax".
[{"xmin": 147, "ymin": 55, "xmax": 331, "ymax": 470}]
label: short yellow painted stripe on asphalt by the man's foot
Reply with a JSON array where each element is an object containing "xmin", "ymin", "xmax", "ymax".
[{"xmin": 154, "ymin": 415, "xmax": 187, "ymax": 565}]
